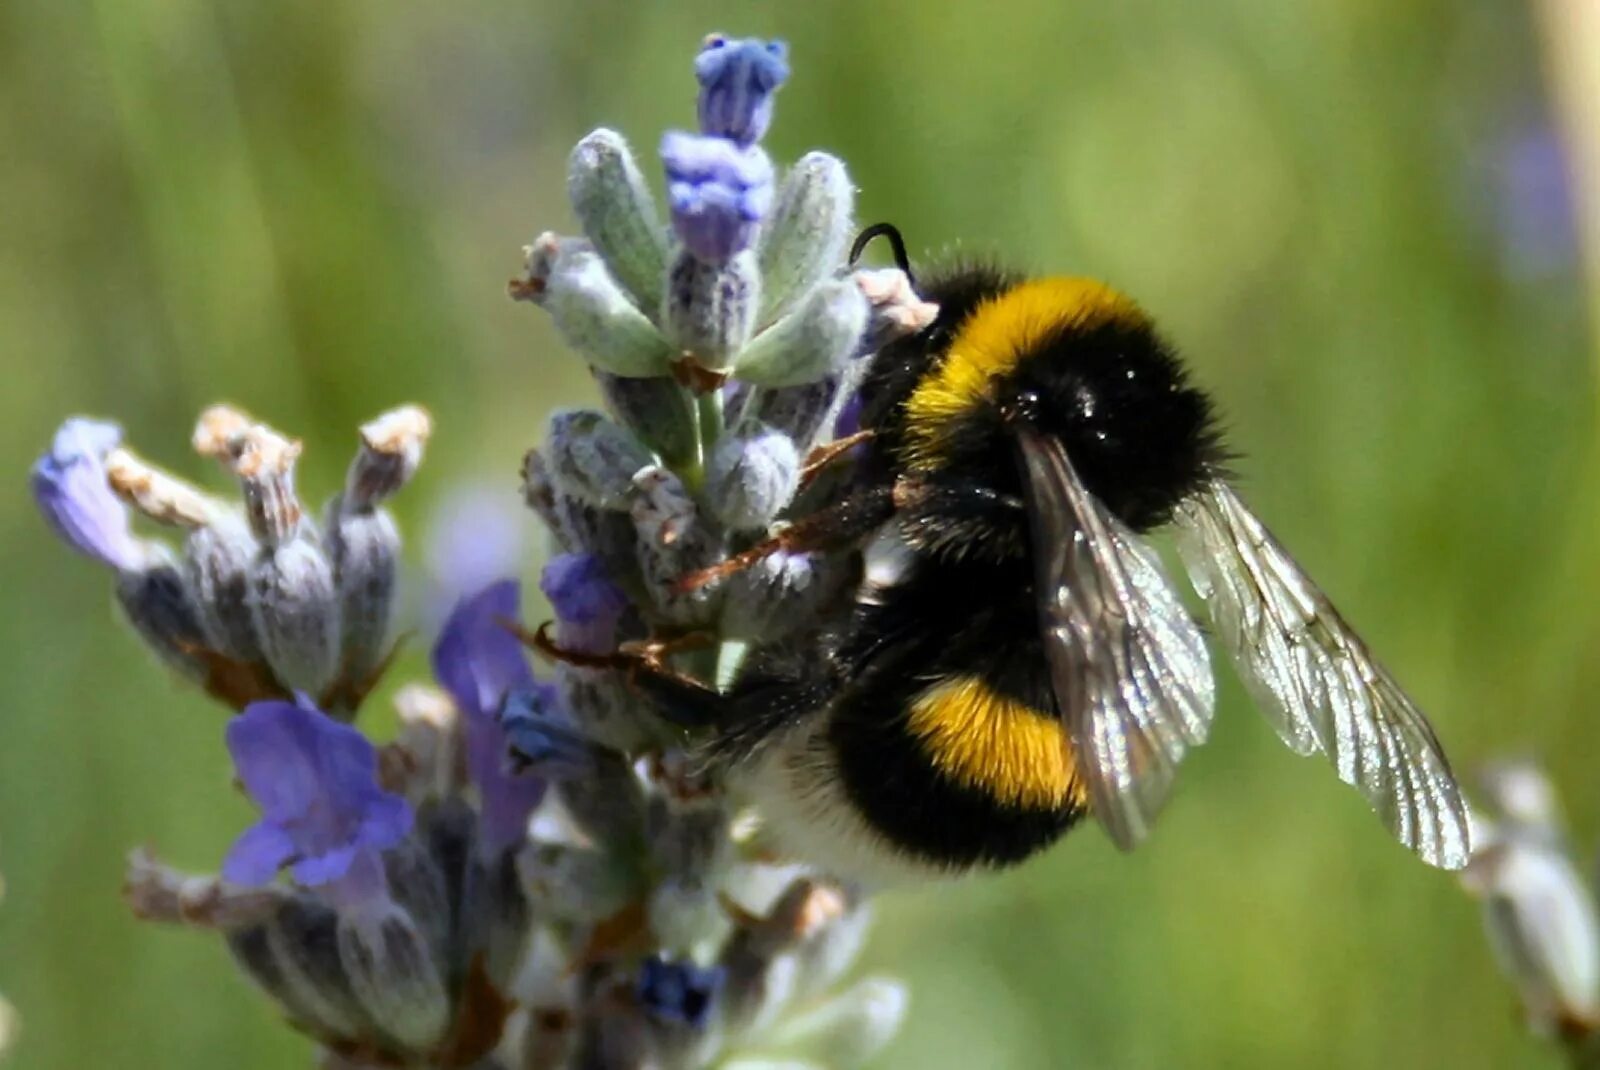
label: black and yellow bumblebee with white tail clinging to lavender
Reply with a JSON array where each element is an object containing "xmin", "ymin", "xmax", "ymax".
[{"xmin": 601, "ymin": 224, "xmax": 1470, "ymax": 883}]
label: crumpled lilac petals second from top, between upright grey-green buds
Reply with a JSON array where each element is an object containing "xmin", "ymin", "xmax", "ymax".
[{"xmin": 661, "ymin": 131, "xmax": 773, "ymax": 264}]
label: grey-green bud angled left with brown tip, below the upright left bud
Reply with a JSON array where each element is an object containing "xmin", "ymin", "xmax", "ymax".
[{"xmin": 510, "ymin": 234, "xmax": 672, "ymax": 376}]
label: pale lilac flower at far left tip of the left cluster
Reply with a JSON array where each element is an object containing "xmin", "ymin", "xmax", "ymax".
[{"xmin": 29, "ymin": 416, "xmax": 144, "ymax": 573}]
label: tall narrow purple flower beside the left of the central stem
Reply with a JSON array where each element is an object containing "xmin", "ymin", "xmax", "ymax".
[{"xmin": 434, "ymin": 581, "xmax": 549, "ymax": 854}]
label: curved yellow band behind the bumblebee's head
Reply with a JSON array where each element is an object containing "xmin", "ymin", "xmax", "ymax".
[{"xmin": 904, "ymin": 278, "xmax": 1146, "ymax": 472}]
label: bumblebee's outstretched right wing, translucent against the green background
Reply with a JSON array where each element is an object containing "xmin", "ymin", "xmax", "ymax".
[{"xmin": 1178, "ymin": 480, "xmax": 1472, "ymax": 870}]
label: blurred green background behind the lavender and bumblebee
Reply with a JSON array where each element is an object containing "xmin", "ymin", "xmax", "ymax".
[{"xmin": 0, "ymin": 0, "xmax": 1600, "ymax": 1070}]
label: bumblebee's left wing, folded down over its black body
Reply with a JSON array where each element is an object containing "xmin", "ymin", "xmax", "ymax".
[{"xmin": 1019, "ymin": 432, "xmax": 1214, "ymax": 849}]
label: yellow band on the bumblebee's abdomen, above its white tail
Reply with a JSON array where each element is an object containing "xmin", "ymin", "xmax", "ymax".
[{"xmin": 907, "ymin": 677, "xmax": 1085, "ymax": 809}]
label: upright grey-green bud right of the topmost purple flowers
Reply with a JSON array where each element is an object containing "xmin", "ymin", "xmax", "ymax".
[{"xmin": 760, "ymin": 152, "xmax": 856, "ymax": 325}]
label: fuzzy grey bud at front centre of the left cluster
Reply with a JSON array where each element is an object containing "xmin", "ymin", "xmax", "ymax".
[{"xmin": 250, "ymin": 529, "xmax": 342, "ymax": 696}]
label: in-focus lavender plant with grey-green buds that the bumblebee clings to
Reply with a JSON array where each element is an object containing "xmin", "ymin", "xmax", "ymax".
[{"xmin": 46, "ymin": 38, "xmax": 933, "ymax": 1070}]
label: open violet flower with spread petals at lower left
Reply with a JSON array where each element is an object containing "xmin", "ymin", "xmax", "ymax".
[{"xmin": 222, "ymin": 701, "xmax": 413, "ymax": 905}]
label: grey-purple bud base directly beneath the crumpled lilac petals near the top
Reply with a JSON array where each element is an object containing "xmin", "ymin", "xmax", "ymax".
[{"xmin": 664, "ymin": 251, "xmax": 762, "ymax": 371}]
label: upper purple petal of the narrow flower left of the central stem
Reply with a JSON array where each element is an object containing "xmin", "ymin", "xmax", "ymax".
[{"xmin": 434, "ymin": 581, "xmax": 533, "ymax": 717}]
